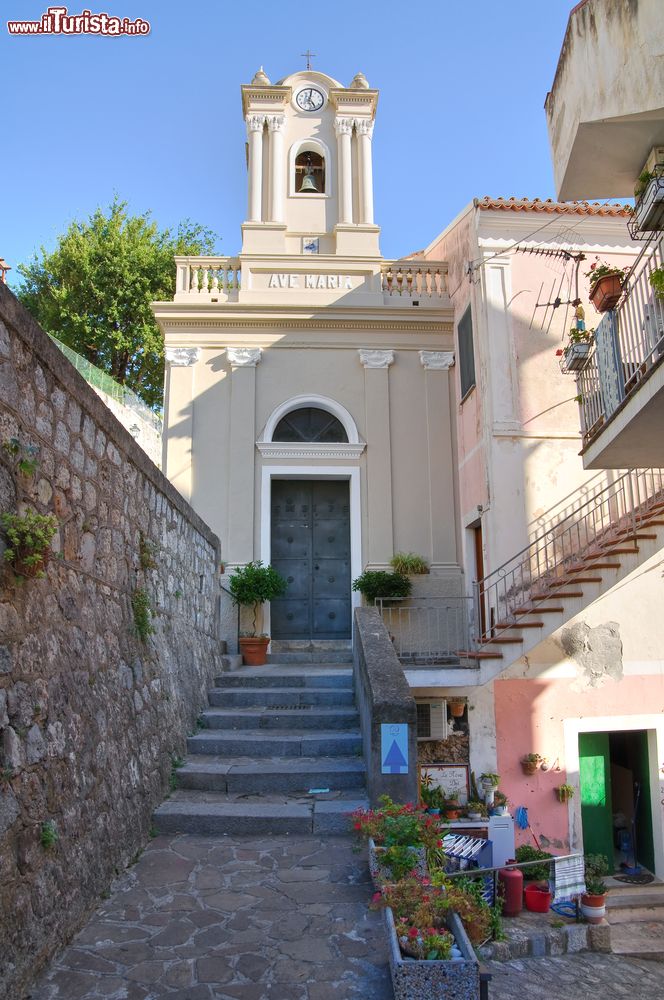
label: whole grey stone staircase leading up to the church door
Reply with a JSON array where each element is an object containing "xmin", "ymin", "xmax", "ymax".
[{"xmin": 154, "ymin": 653, "xmax": 367, "ymax": 835}]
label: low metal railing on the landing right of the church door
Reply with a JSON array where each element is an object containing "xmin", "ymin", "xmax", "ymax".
[{"xmin": 376, "ymin": 597, "xmax": 475, "ymax": 664}]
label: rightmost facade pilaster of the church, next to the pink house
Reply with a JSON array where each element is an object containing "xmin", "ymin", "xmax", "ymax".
[{"xmin": 420, "ymin": 351, "xmax": 457, "ymax": 566}]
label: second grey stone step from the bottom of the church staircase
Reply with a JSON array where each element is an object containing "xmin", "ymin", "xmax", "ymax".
[{"xmin": 177, "ymin": 754, "xmax": 366, "ymax": 794}]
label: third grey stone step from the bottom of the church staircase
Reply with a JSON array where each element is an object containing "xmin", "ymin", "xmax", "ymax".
[{"xmin": 187, "ymin": 729, "xmax": 362, "ymax": 757}]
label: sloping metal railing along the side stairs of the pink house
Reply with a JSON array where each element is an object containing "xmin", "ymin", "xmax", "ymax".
[{"xmin": 474, "ymin": 469, "xmax": 664, "ymax": 645}]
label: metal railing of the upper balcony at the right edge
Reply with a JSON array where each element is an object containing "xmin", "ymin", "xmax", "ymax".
[{"xmin": 576, "ymin": 236, "xmax": 664, "ymax": 445}]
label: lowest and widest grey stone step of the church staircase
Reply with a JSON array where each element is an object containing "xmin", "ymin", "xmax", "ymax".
[{"xmin": 153, "ymin": 791, "xmax": 367, "ymax": 836}]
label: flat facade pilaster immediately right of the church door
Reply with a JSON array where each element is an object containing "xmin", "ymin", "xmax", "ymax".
[{"xmin": 358, "ymin": 348, "xmax": 394, "ymax": 569}]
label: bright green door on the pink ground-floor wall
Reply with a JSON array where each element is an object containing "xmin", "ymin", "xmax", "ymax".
[{"xmin": 579, "ymin": 733, "xmax": 614, "ymax": 870}]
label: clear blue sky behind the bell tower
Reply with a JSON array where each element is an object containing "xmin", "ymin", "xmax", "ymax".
[{"xmin": 0, "ymin": 0, "xmax": 573, "ymax": 280}]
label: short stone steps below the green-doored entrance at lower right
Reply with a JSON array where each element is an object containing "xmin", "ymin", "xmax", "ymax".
[{"xmin": 606, "ymin": 882, "xmax": 664, "ymax": 962}]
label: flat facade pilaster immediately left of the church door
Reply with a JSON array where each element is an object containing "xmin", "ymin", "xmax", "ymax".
[{"xmin": 226, "ymin": 347, "xmax": 263, "ymax": 566}]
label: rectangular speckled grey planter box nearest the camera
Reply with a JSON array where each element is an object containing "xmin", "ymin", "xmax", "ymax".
[{"xmin": 385, "ymin": 908, "xmax": 480, "ymax": 1000}]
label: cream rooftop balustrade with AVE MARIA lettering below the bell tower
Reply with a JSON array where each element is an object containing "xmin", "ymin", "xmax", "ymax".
[{"xmin": 174, "ymin": 254, "xmax": 450, "ymax": 310}]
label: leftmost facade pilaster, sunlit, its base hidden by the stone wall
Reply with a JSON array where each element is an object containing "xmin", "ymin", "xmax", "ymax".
[{"xmin": 162, "ymin": 347, "xmax": 201, "ymax": 500}]
